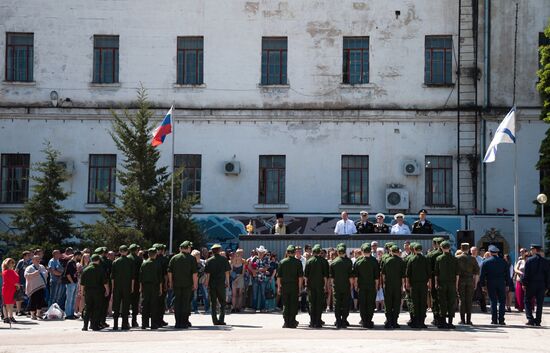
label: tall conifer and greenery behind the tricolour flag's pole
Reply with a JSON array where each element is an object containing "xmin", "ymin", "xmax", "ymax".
[{"xmin": 85, "ymin": 87, "xmax": 204, "ymax": 251}]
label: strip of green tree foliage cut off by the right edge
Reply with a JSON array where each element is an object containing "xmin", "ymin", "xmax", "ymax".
[{"xmin": 537, "ymin": 25, "xmax": 550, "ymax": 253}]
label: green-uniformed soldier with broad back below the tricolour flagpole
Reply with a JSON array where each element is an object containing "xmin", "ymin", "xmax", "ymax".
[{"xmin": 168, "ymin": 240, "xmax": 198, "ymax": 328}]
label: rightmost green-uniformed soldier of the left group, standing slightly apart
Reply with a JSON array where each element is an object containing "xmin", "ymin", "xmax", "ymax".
[{"xmin": 204, "ymin": 244, "xmax": 231, "ymax": 325}]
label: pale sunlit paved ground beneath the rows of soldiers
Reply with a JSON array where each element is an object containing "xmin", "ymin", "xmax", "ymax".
[{"xmin": 0, "ymin": 307, "xmax": 550, "ymax": 353}]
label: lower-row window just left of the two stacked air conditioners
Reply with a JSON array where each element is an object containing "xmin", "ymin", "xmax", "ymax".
[{"xmin": 341, "ymin": 156, "xmax": 369, "ymax": 205}]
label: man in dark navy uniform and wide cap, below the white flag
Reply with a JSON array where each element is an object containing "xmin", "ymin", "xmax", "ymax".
[{"xmin": 479, "ymin": 245, "xmax": 512, "ymax": 325}]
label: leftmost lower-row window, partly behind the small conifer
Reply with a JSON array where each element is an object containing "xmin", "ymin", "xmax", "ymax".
[{"xmin": 0, "ymin": 154, "xmax": 31, "ymax": 203}]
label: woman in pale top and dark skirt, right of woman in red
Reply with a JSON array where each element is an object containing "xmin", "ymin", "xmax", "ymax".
[{"xmin": 25, "ymin": 255, "xmax": 48, "ymax": 320}]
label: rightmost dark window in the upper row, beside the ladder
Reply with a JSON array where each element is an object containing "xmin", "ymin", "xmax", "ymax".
[{"xmin": 424, "ymin": 36, "xmax": 453, "ymax": 85}]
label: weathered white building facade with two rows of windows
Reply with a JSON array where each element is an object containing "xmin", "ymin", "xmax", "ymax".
[{"xmin": 0, "ymin": 0, "xmax": 550, "ymax": 248}]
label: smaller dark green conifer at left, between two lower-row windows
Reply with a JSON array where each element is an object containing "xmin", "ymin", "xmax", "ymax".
[{"xmin": 13, "ymin": 142, "xmax": 72, "ymax": 244}]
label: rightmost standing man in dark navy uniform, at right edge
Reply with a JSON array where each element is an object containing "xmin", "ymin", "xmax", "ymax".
[{"xmin": 524, "ymin": 244, "xmax": 550, "ymax": 326}]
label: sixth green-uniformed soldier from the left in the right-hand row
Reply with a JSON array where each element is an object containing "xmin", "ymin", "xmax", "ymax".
[{"xmin": 406, "ymin": 244, "xmax": 432, "ymax": 328}]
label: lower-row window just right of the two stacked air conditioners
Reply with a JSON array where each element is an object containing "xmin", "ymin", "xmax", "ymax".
[{"xmin": 425, "ymin": 156, "xmax": 453, "ymax": 207}]
